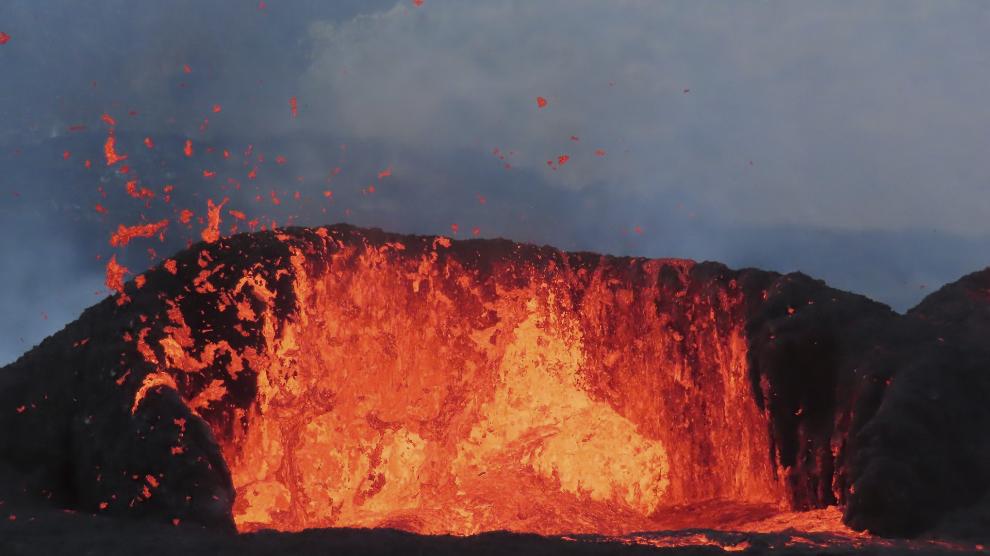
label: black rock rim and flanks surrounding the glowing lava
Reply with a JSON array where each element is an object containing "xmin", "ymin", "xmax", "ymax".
[{"xmin": 0, "ymin": 225, "xmax": 990, "ymax": 538}]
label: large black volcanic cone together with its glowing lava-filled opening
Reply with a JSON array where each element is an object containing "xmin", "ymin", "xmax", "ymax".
[{"xmin": 0, "ymin": 226, "xmax": 990, "ymax": 534}]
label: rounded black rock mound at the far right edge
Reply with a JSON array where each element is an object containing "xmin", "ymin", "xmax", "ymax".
[{"xmin": 846, "ymin": 269, "xmax": 990, "ymax": 536}]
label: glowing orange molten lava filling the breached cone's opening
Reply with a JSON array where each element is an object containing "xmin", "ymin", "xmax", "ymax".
[{"xmin": 132, "ymin": 226, "xmax": 787, "ymax": 534}]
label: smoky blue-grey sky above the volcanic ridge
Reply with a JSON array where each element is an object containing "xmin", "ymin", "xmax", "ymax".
[{"xmin": 0, "ymin": 0, "xmax": 990, "ymax": 362}]
